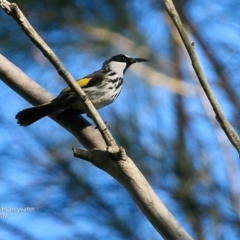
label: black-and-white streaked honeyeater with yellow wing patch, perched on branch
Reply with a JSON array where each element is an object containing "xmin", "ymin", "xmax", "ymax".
[{"xmin": 16, "ymin": 54, "xmax": 148, "ymax": 127}]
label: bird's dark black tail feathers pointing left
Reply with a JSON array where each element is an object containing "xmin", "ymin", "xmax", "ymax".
[{"xmin": 16, "ymin": 103, "xmax": 57, "ymax": 127}]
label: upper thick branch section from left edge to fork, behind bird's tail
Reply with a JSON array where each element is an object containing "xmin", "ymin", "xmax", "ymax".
[{"xmin": 0, "ymin": 54, "xmax": 106, "ymax": 149}]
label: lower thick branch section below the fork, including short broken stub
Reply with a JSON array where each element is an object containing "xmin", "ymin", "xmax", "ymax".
[{"xmin": 73, "ymin": 148, "xmax": 192, "ymax": 240}]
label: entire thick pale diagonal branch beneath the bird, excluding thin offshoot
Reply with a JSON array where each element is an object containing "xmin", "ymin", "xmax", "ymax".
[{"xmin": 0, "ymin": 54, "xmax": 191, "ymax": 240}]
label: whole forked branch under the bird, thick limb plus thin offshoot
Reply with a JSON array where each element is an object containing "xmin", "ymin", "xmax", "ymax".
[{"xmin": 0, "ymin": 0, "xmax": 191, "ymax": 240}]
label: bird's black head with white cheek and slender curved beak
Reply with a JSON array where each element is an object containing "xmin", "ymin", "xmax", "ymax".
[{"xmin": 102, "ymin": 54, "xmax": 148, "ymax": 76}]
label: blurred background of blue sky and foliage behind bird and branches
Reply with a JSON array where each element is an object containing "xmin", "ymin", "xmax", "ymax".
[{"xmin": 0, "ymin": 0, "xmax": 240, "ymax": 240}]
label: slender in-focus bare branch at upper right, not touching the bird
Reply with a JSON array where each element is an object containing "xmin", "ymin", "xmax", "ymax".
[{"xmin": 164, "ymin": 0, "xmax": 240, "ymax": 154}]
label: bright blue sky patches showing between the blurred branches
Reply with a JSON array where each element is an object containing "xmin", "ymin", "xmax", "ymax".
[{"xmin": 0, "ymin": 1, "xmax": 240, "ymax": 239}]
